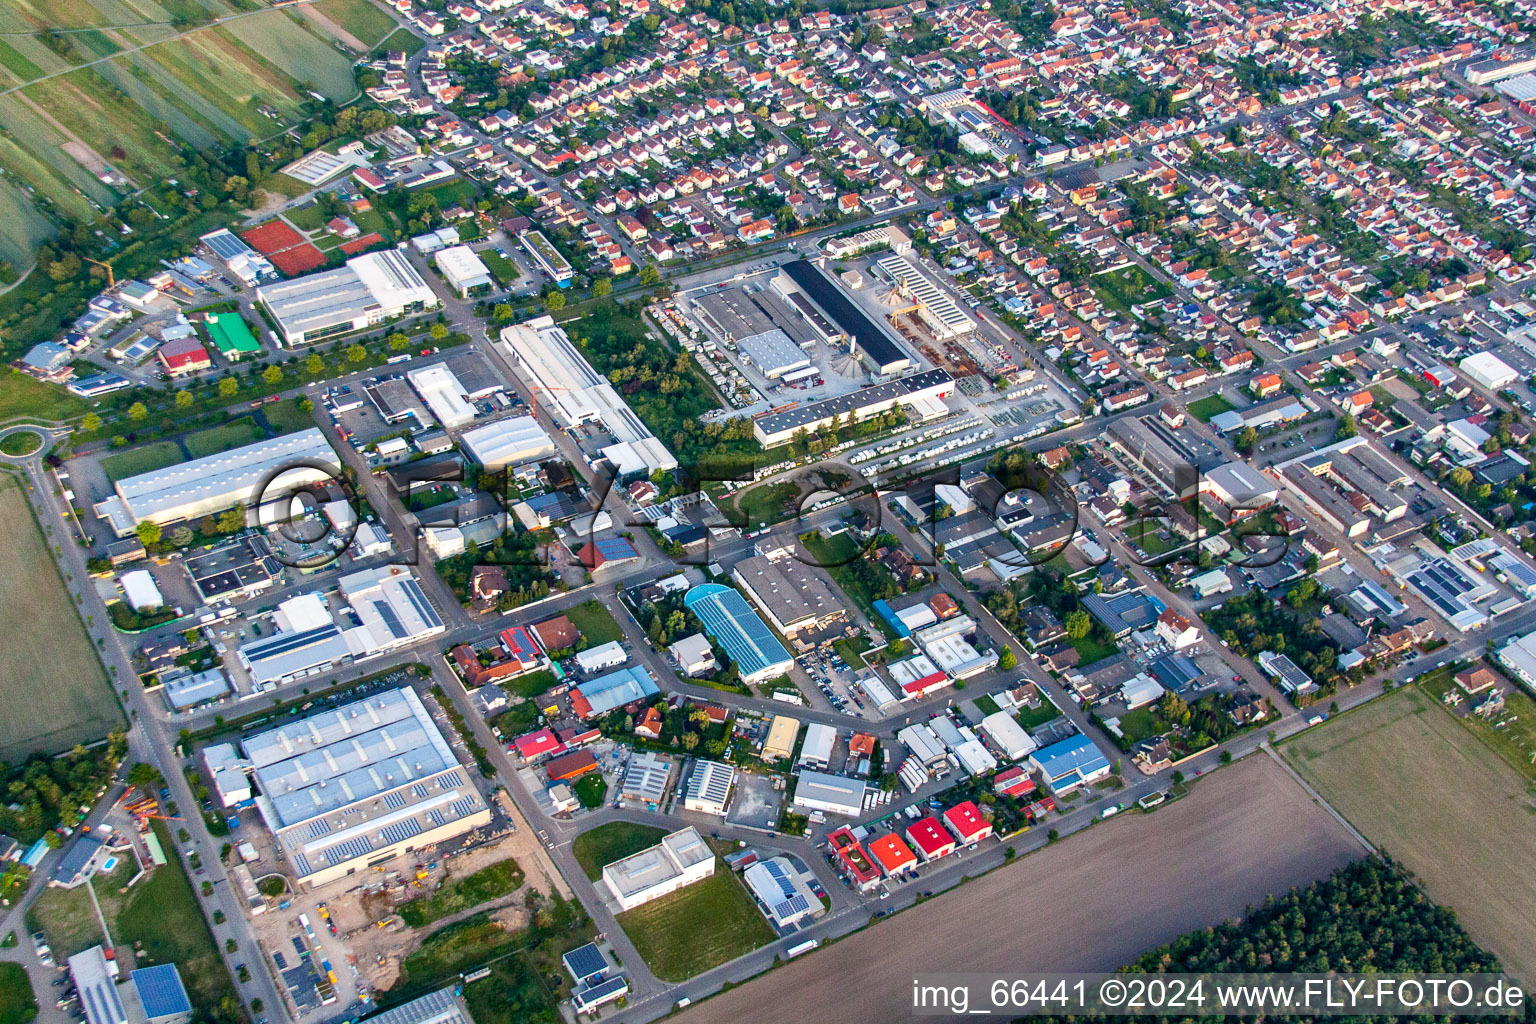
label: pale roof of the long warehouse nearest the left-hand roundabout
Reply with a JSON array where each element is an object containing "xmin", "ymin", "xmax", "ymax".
[{"xmin": 105, "ymin": 427, "xmax": 341, "ymax": 522}]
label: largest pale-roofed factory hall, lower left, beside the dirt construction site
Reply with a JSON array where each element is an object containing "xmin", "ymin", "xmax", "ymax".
[{"xmin": 243, "ymin": 688, "xmax": 490, "ymax": 886}]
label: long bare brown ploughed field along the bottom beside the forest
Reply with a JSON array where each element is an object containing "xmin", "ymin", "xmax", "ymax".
[{"xmin": 676, "ymin": 754, "xmax": 1364, "ymax": 1024}]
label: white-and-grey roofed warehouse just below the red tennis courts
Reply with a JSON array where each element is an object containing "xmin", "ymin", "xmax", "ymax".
[{"xmin": 257, "ymin": 249, "xmax": 438, "ymax": 345}]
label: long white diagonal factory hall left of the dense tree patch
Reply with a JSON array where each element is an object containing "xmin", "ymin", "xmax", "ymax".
[{"xmin": 498, "ymin": 316, "xmax": 677, "ymax": 476}]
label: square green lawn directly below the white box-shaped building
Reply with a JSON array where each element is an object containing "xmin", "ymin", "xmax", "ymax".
[{"xmin": 617, "ymin": 858, "xmax": 776, "ymax": 981}]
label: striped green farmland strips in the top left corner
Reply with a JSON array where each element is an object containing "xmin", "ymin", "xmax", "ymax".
[{"xmin": 0, "ymin": 0, "xmax": 359, "ymax": 269}]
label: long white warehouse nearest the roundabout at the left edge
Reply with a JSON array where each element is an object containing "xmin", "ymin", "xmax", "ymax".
[{"xmin": 95, "ymin": 427, "xmax": 341, "ymax": 537}]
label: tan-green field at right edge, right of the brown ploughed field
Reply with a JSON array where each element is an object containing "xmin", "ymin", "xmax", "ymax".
[{"xmin": 1281, "ymin": 686, "xmax": 1536, "ymax": 984}]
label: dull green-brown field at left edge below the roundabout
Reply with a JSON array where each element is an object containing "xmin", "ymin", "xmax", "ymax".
[{"xmin": 0, "ymin": 474, "xmax": 123, "ymax": 761}]
